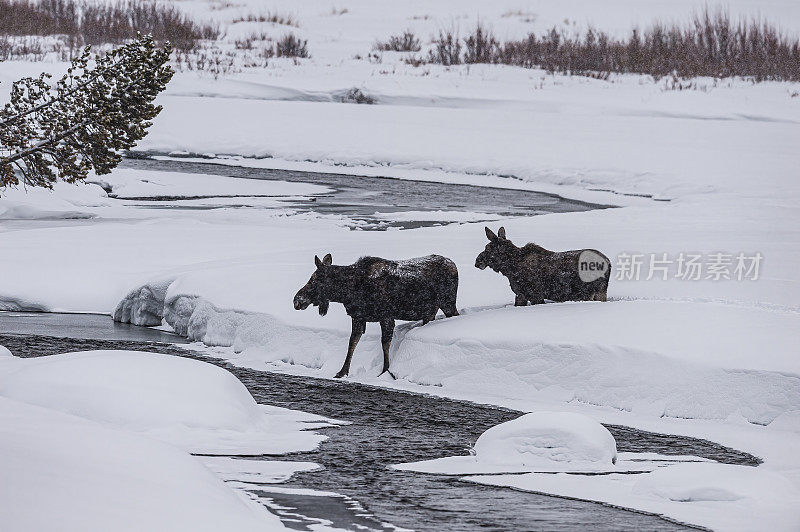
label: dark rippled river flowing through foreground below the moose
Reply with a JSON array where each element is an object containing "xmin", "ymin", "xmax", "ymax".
[{"xmin": 0, "ymin": 313, "xmax": 758, "ymax": 531}]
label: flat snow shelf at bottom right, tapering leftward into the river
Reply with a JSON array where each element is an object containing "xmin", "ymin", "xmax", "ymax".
[{"xmin": 464, "ymin": 463, "xmax": 800, "ymax": 531}]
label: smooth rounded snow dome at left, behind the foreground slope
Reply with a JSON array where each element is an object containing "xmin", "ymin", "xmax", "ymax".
[{"xmin": 0, "ymin": 351, "xmax": 260, "ymax": 430}]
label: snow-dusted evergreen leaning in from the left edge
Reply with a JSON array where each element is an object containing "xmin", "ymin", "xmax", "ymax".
[{"xmin": 0, "ymin": 36, "xmax": 174, "ymax": 188}]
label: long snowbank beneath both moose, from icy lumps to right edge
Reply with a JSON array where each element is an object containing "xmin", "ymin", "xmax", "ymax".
[{"xmin": 145, "ymin": 287, "xmax": 800, "ymax": 425}]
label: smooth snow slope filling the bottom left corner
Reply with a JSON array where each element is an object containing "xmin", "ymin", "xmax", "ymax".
[{"xmin": 0, "ymin": 397, "xmax": 284, "ymax": 532}]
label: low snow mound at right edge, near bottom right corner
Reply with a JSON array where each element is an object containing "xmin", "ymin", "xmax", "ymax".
[{"xmin": 633, "ymin": 463, "xmax": 800, "ymax": 502}]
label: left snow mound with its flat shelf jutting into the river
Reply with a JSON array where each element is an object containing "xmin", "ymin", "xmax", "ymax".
[{"xmin": 0, "ymin": 351, "xmax": 326, "ymax": 454}]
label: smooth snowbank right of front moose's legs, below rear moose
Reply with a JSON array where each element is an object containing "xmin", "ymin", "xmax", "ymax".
[{"xmin": 392, "ymin": 301, "xmax": 800, "ymax": 424}]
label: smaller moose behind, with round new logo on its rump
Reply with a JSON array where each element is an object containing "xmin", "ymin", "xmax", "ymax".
[{"xmin": 475, "ymin": 227, "xmax": 611, "ymax": 307}]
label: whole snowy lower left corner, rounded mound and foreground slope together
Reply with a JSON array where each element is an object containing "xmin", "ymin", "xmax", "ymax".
[{"xmin": 0, "ymin": 348, "xmax": 338, "ymax": 532}]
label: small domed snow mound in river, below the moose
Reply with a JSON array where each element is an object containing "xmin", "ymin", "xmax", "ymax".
[{"xmin": 475, "ymin": 412, "xmax": 617, "ymax": 466}]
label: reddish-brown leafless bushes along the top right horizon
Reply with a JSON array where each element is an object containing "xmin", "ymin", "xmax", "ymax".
[{"xmin": 422, "ymin": 10, "xmax": 800, "ymax": 81}]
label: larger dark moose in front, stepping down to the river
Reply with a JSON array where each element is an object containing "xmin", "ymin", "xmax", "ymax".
[{"xmin": 294, "ymin": 253, "xmax": 458, "ymax": 379}]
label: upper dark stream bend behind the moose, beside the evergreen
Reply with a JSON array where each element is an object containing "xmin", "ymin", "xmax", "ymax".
[{"xmin": 119, "ymin": 157, "xmax": 605, "ymax": 230}]
